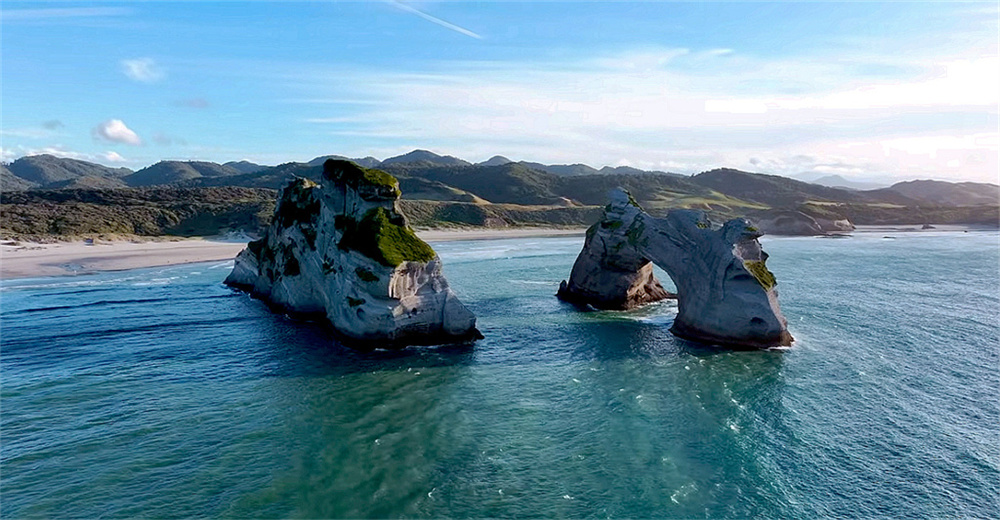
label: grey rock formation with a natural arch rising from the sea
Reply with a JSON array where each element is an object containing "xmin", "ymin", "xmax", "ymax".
[{"xmin": 559, "ymin": 189, "xmax": 792, "ymax": 348}]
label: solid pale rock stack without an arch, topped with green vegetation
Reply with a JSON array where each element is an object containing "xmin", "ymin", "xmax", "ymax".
[{"xmin": 225, "ymin": 160, "xmax": 482, "ymax": 348}]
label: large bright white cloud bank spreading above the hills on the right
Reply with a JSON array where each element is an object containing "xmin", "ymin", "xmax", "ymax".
[{"xmin": 290, "ymin": 45, "xmax": 1000, "ymax": 182}]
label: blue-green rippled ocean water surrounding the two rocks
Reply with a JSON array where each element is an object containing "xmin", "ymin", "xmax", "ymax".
[{"xmin": 0, "ymin": 231, "xmax": 1000, "ymax": 519}]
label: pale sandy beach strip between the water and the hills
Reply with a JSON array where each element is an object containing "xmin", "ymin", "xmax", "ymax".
[{"xmin": 0, "ymin": 228, "xmax": 585, "ymax": 280}]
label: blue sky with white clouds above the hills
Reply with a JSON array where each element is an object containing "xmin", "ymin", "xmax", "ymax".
[{"xmin": 0, "ymin": 0, "xmax": 1000, "ymax": 183}]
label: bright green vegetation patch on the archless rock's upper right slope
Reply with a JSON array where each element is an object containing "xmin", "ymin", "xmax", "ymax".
[{"xmin": 339, "ymin": 208, "xmax": 437, "ymax": 267}]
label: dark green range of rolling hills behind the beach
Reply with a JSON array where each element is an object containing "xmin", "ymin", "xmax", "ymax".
[{"xmin": 0, "ymin": 150, "xmax": 1000, "ymax": 239}]
